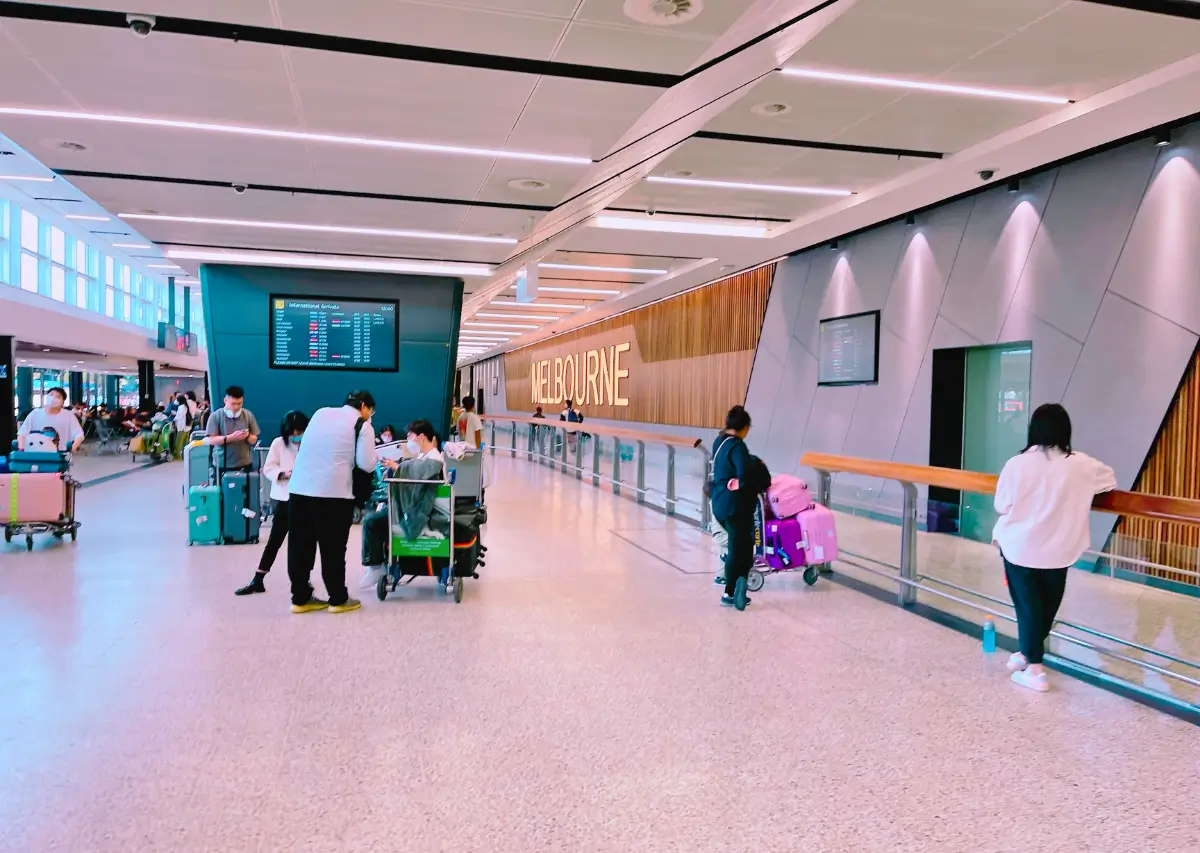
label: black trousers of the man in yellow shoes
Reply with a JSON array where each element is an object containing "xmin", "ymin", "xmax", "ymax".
[{"xmin": 288, "ymin": 494, "xmax": 354, "ymax": 606}]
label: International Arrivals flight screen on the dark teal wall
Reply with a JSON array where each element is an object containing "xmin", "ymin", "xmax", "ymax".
[{"xmin": 271, "ymin": 295, "xmax": 400, "ymax": 371}]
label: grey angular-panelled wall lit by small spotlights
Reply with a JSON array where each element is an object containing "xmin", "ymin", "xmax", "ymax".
[{"xmin": 748, "ymin": 126, "xmax": 1200, "ymax": 542}]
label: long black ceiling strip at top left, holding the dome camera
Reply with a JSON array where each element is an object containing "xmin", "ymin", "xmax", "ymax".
[{"xmin": 0, "ymin": 0, "xmax": 683, "ymax": 89}]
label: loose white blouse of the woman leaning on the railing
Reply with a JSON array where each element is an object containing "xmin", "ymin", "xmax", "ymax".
[{"xmin": 992, "ymin": 447, "xmax": 1117, "ymax": 569}]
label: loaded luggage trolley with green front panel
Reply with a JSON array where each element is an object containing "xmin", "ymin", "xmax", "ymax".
[{"xmin": 376, "ymin": 452, "xmax": 485, "ymax": 603}]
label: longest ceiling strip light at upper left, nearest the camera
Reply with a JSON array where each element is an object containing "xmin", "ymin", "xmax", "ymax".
[{"xmin": 0, "ymin": 107, "xmax": 593, "ymax": 166}]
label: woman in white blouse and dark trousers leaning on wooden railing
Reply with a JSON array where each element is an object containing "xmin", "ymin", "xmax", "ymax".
[{"xmin": 992, "ymin": 403, "xmax": 1117, "ymax": 693}]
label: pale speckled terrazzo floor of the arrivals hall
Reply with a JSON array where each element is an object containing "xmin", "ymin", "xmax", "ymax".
[{"xmin": 0, "ymin": 456, "xmax": 1200, "ymax": 853}]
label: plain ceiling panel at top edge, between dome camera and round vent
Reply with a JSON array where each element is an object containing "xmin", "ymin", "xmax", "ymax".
[{"xmin": 276, "ymin": 0, "xmax": 566, "ymax": 59}]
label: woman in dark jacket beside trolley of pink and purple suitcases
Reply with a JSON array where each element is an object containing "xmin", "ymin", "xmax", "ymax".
[{"xmin": 710, "ymin": 406, "xmax": 770, "ymax": 611}]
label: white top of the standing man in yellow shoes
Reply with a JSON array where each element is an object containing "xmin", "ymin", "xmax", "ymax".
[{"xmin": 288, "ymin": 406, "xmax": 378, "ymax": 500}]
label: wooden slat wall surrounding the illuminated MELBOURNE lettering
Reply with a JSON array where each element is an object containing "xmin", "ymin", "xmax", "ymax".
[{"xmin": 504, "ymin": 264, "xmax": 775, "ymax": 427}]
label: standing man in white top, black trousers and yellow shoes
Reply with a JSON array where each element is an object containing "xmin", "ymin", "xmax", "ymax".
[{"xmin": 288, "ymin": 391, "xmax": 378, "ymax": 613}]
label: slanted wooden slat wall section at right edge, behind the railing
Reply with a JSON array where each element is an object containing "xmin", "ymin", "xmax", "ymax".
[{"xmin": 1109, "ymin": 353, "xmax": 1200, "ymax": 585}]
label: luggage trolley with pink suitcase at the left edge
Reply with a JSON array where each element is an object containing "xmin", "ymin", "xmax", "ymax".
[{"xmin": 0, "ymin": 451, "xmax": 80, "ymax": 551}]
